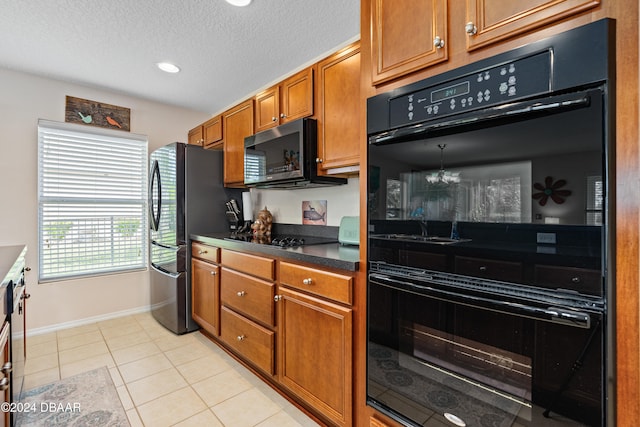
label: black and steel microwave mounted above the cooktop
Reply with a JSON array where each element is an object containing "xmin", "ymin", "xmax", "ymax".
[{"xmin": 244, "ymin": 118, "xmax": 347, "ymax": 188}]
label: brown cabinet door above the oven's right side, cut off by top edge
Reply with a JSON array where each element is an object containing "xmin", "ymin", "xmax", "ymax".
[{"xmin": 464, "ymin": 0, "xmax": 600, "ymax": 50}]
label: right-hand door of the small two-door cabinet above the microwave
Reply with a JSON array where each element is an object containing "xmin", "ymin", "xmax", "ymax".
[{"xmin": 280, "ymin": 67, "xmax": 313, "ymax": 123}]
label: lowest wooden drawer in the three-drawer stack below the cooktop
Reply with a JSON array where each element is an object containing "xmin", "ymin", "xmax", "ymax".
[{"xmin": 220, "ymin": 306, "xmax": 275, "ymax": 375}]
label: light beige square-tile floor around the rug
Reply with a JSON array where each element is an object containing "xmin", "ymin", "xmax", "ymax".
[{"xmin": 24, "ymin": 313, "xmax": 317, "ymax": 427}]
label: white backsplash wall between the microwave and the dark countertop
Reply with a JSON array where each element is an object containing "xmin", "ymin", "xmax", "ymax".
[{"xmin": 251, "ymin": 178, "xmax": 360, "ymax": 226}]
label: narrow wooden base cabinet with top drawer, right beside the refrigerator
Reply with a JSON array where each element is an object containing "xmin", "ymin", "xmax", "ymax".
[{"xmin": 191, "ymin": 243, "xmax": 220, "ymax": 336}]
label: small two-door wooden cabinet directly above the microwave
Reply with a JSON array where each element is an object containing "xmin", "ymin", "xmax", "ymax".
[{"xmin": 255, "ymin": 67, "xmax": 313, "ymax": 132}]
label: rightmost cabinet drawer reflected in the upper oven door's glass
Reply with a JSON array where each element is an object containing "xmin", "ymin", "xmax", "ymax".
[{"xmin": 534, "ymin": 265, "xmax": 602, "ymax": 296}]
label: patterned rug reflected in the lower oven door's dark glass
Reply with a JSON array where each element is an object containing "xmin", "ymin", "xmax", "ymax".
[{"xmin": 368, "ymin": 342, "xmax": 519, "ymax": 427}]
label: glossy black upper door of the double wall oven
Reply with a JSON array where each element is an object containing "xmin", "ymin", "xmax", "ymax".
[{"xmin": 368, "ymin": 88, "xmax": 607, "ymax": 296}]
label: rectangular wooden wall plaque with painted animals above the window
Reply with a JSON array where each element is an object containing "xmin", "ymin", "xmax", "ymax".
[{"xmin": 64, "ymin": 95, "xmax": 131, "ymax": 131}]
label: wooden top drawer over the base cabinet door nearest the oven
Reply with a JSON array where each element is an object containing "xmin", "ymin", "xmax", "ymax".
[{"xmin": 280, "ymin": 262, "xmax": 353, "ymax": 305}]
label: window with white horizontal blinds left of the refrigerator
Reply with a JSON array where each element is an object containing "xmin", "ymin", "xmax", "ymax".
[{"xmin": 38, "ymin": 120, "xmax": 148, "ymax": 281}]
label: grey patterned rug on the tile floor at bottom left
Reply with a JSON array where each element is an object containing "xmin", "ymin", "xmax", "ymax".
[{"xmin": 16, "ymin": 367, "xmax": 130, "ymax": 427}]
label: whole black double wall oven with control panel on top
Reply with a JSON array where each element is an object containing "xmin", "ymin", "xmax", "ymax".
[{"xmin": 367, "ymin": 20, "xmax": 615, "ymax": 426}]
